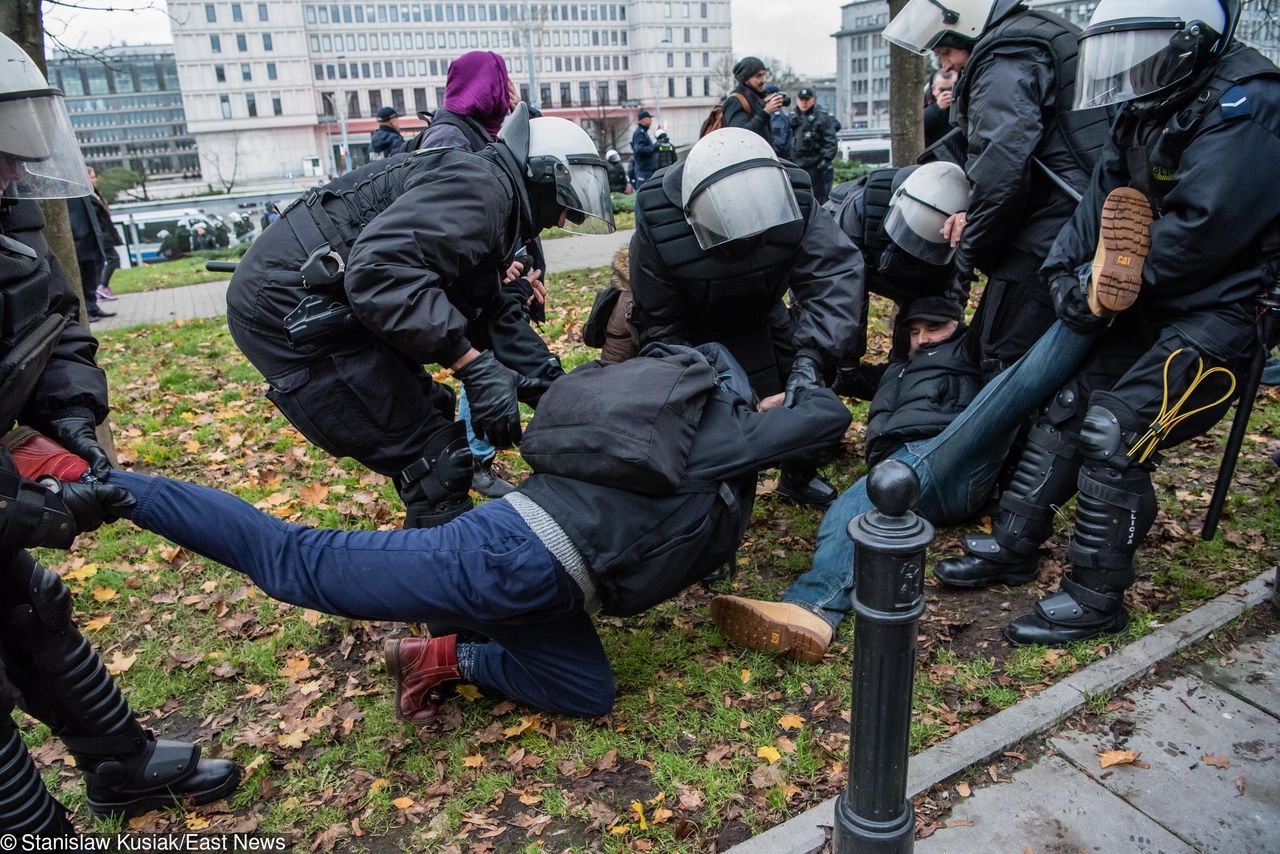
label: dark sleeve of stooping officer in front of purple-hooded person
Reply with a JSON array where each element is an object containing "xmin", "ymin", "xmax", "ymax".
[{"xmin": 344, "ymin": 182, "xmax": 509, "ymax": 367}]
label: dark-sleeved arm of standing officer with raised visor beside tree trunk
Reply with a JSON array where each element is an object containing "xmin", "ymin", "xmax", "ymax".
[{"xmin": 957, "ymin": 51, "xmax": 1055, "ymax": 273}]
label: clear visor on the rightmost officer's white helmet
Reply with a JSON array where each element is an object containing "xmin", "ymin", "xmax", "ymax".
[{"xmin": 1074, "ymin": 19, "xmax": 1197, "ymax": 110}]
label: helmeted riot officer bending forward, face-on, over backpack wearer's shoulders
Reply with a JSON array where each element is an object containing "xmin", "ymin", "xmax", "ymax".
[{"xmin": 631, "ymin": 128, "xmax": 863, "ymax": 507}]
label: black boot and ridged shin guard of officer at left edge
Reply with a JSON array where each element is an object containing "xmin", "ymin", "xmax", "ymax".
[{"xmin": 6, "ymin": 554, "xmax": 241, "ymax": 816}]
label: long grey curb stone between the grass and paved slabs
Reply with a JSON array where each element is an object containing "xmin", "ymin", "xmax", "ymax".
[{"xmin": 727, "ymin": 568, "xmax": 1276, "ymax": 854}]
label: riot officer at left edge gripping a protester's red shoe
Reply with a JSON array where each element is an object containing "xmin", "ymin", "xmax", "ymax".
[{"xmin": 0, "ymin": 36, "xmax": 239, "ymax": 834}]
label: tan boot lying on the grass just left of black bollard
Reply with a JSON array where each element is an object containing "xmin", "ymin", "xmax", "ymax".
[{"xmin": 712, "ymin": 595, "xmax": 832, "ymax": 662}]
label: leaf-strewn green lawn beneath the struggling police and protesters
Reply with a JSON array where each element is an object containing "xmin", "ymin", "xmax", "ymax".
[{"xmin": 23, "ymin": 269, "xmax": 1280, "ymax": 853}]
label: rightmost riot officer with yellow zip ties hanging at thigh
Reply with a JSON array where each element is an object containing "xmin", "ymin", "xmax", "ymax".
[{"xmin": 934, "ymin": 0, "xmax": 1280, "ymax": 647}]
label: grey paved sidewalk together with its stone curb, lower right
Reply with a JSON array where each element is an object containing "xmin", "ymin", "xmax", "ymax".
[{"xmin": 731, "ymin": 571, "xmax": 1280, "ymax": 854}]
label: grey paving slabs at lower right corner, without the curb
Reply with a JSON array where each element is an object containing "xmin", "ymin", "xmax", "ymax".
[{"xmin": 915, "ymin": 635, "xmax": 1280, "ymax": 854}]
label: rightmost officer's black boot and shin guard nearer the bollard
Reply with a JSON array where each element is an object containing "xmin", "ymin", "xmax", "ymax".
[{"xmin": 933, "ymin": 423, "xmax": 1080, "ymax": 589}]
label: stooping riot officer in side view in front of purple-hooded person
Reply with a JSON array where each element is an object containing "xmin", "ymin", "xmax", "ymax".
[{"xmin": 227, "ymin": 105, "xmax": 613, "ymax": 526}]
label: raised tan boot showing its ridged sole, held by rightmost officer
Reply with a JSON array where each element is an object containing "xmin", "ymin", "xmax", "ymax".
[{"xmin": 1089, "ymin": 187, "xmax": 1152, "ymax": 318}]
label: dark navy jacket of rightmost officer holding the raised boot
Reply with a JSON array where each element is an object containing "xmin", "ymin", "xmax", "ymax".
[{"xmin": 1042, "ymin": 45, "xmax": 1280, "ymax": 332}]
